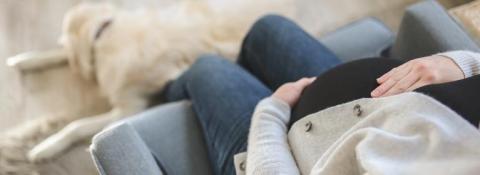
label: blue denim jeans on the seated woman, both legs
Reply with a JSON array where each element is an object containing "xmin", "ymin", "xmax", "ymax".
[{"xmin": 166, "ymin": 15, "xmax": 340, "ymax": 175}]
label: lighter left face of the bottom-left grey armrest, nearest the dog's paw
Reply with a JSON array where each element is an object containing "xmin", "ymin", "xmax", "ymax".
[{"xmin": 90, "ymin": 123, "xmax": 162, "ymax": 175}]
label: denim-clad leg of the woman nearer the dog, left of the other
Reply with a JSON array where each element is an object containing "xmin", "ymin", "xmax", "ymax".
[{"xmin": 166, "ymin": 56, "xmax": 271, "ymax": 175}]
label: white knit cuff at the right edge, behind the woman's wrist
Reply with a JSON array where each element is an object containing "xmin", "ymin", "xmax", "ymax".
[{"xmin": 437, "ymin": 50, "xmax": 480, "ymax": 78}]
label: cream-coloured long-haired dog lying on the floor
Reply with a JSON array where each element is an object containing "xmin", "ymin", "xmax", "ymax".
[{"xmin": 4, "ymin": 0, "xmax": 293, "ymax": 165}]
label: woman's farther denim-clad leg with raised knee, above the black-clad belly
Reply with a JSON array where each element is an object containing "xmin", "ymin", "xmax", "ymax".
[{"xmin": 238, "ymin": 15, "xmax": 341, "ymax": 90}]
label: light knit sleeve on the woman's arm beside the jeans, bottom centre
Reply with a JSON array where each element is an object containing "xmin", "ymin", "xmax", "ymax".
[{"xmin": 246, "ymin": 97, "xmax": 300, "ymax": 175}]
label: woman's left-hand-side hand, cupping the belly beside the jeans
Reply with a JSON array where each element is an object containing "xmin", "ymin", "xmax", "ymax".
[{"xmin": 272, "ymin": 78, "xmax": 316, "ymax": 107}]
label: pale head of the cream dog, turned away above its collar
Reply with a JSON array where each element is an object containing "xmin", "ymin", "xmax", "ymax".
[{"xmin": 59, "ymin": 3, "xmax": 115, "ymax": 80}]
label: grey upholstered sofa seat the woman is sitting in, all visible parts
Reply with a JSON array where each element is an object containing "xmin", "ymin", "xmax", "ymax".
[{"xmin": 91, "ymin": 1, "xmax": 479, "ymax": 175}]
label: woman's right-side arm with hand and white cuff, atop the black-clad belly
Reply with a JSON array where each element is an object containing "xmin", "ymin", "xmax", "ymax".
[{"xmin": 371, "ymin": 51, "xmax": 480, "ymax": 97}]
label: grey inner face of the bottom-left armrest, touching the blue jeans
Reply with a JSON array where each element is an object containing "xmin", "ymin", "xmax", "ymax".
[{"xmin": 126, "ymin": 101, "xmax": 213, "ymax": 175}]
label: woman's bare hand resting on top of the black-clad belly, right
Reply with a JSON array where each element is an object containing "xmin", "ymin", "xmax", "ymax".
[{"xmin": 371, "ymin": 55, "xmax": 465, "ymax": 97}]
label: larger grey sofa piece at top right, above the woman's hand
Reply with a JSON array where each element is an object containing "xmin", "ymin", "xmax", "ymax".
[{"xmin": 388, "ymin": 0, "xmax": 479, "ymax": 60}]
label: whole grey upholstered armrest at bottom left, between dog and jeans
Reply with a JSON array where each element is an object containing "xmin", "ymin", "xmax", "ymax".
[{"xmin": 90, "ymin": 101, "xmax": 211, "ymax": 175}]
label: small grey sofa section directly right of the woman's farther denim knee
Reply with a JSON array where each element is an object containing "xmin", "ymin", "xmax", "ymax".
[{"xmin": 320, "ymin": 18, "xmax": 395, "ymax": 62}]
